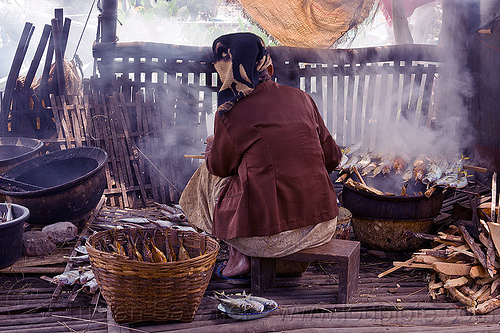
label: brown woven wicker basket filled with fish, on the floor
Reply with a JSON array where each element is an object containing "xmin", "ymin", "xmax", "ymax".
[{"xmin": 86, "ymin": 228, "xmax": 219, "ymax": 323}]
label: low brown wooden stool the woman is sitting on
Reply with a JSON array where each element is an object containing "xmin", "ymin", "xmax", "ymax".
[{"xmin": 251, "ymin": 239, "xmax": 360, "ymax": 304}]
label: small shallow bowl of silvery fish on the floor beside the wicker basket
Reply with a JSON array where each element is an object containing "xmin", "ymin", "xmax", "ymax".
[{"xmin": 213, "ymin": 291, "xmax": 278, "ymax": 320}]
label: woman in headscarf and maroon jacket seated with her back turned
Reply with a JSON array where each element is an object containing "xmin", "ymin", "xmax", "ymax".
[{"xmin": 180, "ymin": 33, "xmax": 341, "ymax": 277}]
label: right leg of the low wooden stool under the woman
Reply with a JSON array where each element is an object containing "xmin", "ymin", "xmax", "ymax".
[{"xmin": 338, "ymin": 240, "xmax": 360, "ymax": 304}]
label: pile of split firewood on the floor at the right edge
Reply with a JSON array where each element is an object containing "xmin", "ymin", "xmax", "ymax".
[{"xmin": 378, "ymin": 174, "xmax": 500, "ymax": 315}]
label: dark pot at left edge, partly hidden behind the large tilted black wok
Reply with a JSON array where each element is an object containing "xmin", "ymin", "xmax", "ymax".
[{"xmin": 0, "ymin": 137, "xmax": 43, "ymax": 174}]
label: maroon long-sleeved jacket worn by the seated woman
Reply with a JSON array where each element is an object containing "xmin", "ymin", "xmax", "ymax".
[{"xmin": 205, "ymin": 81, "xmax": 341, "ymax": 239}]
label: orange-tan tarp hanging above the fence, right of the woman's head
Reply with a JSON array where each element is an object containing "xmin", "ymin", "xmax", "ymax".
[{"xmin": 239, "ymin": 0, "xmax": 376, "ymax": 48}]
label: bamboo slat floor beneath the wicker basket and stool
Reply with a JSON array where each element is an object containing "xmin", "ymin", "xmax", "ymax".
[{"xmin": 0, "ymin": 179, "xmax": 500, "ymax": 333}]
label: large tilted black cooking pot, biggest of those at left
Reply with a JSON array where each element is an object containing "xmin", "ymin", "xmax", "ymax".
[{"xmin": 0, "ymin": 147, "xmax": 108, "ymax": 225}]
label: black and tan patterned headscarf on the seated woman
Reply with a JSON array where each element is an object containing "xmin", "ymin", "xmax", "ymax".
[{"xmin": 212, "ymin": 32, "xmax": 272, "ymax": 115}]
